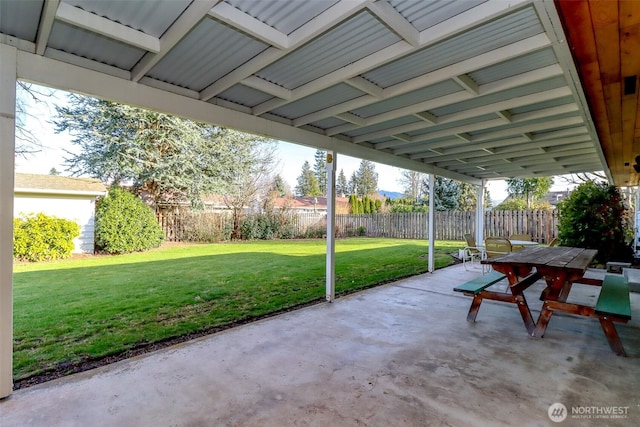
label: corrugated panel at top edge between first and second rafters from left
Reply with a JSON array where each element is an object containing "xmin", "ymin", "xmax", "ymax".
[{"xmin": 63, "ymin": 0, "xmax": 191, "ymax": 37}]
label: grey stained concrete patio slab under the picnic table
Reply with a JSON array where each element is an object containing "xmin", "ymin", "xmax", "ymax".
[{"xmin": 0, "ymin": 265, "xmax": 640, "ymax": 427}]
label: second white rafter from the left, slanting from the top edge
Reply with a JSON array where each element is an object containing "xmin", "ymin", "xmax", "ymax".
[{"xmin": 131, "ymin": 0, "xmax": 221, "ymax": 82}]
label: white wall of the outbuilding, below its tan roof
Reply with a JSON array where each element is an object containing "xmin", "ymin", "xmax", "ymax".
[{"xmin": 13, "ymin": 193, "xmax": 95, "ymax": 253}]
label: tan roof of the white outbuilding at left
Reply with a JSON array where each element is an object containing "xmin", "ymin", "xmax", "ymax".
[{"xmin": 14, "ymin": 173, "xmax": 107, "ymax": 196}]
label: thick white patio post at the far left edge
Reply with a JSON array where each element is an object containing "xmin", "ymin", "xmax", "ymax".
[{"xmin": 0, "ymin": 44, "xmax": 17, "ymax": 399}]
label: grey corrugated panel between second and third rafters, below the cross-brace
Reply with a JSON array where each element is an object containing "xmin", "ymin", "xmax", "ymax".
[{"xmin": 149, "ymin": 19, "xmax": 268, "ymax": 91}]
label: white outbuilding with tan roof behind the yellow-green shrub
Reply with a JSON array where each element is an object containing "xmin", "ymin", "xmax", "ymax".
[{"xmin": 13, "ymin": 173, "xmax": 107, "ymax": 253}]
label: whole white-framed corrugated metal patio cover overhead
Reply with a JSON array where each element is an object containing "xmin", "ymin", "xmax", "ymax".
[{"xmin": 0, "ymin": 0, "xmax": 611, "ymax": 184}]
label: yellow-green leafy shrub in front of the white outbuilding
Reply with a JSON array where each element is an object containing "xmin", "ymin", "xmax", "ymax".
[{"xmin": 13, "ymin": 213, "xmax": 80, "ymax": 261}]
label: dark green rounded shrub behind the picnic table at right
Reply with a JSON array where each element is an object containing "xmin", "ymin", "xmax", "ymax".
[{"xmin": 558, "ymin": 182, "xmax": 632, "ymax": 263}]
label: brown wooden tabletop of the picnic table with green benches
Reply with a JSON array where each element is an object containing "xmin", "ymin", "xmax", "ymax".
[{"xmin": 482, "ymin": 246, "xmax": 598, "ymax": 273}]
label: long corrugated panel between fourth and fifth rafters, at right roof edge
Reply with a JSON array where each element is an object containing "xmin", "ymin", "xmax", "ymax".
[{"xmin": 363, "ymin": 8, "xmax": 543, "ymax": 88}]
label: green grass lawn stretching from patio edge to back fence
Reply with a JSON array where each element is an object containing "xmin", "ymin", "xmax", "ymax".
[{"xmin": 14, "ymin": 238, "xmax": 464, "ymax": 379}]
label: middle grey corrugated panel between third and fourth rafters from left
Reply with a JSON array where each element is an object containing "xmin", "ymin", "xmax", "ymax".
[{"xmin": 257, "ymin": 12, "xmax": 400, "ymax": 89}]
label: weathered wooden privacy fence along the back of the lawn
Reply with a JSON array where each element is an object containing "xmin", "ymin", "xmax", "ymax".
[{"xmin": 157, "ymin": 209, "xmax": 558, "ymax": 243}]
